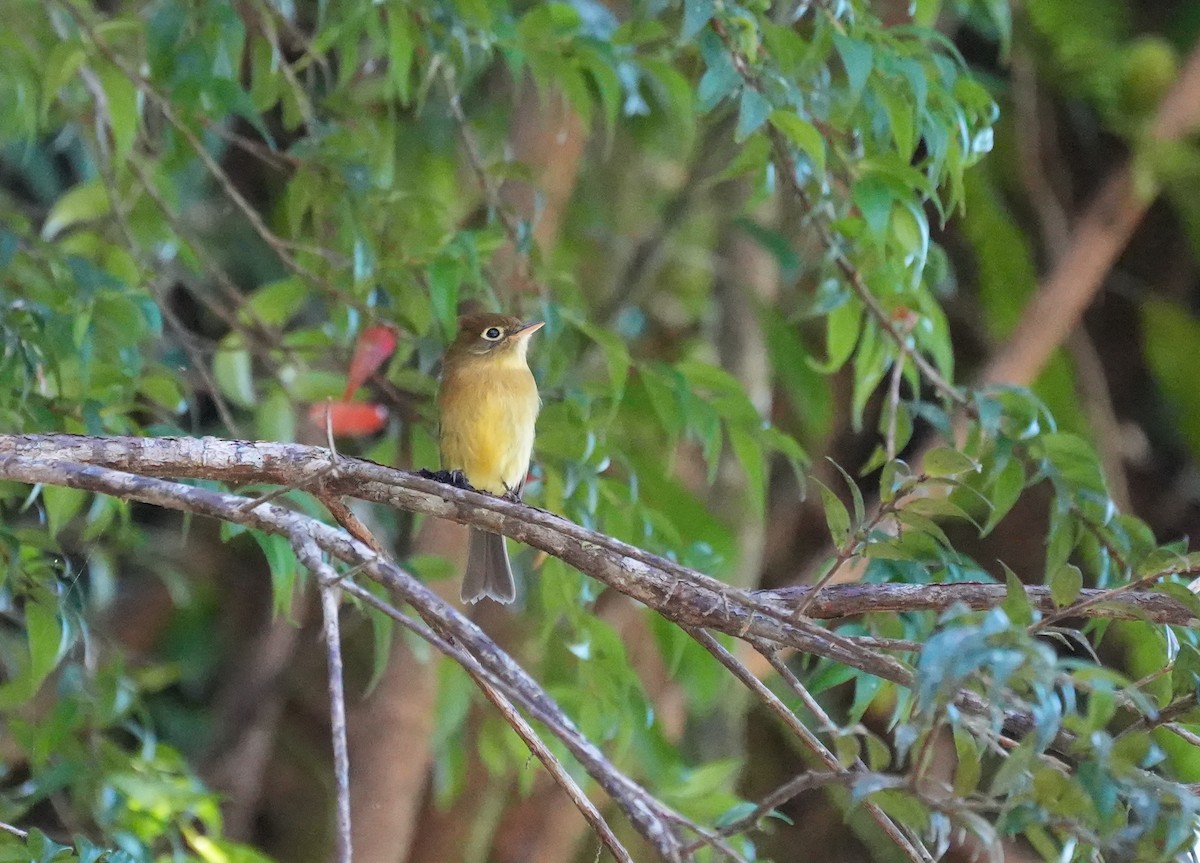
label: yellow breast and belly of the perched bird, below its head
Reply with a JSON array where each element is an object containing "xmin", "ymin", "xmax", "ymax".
[{"xmin": 438, "ymin": 361, "xmax": 541, "ymax": 495}]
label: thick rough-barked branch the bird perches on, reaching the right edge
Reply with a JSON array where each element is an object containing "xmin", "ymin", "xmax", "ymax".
[{"xmin": 0, "ymin": 435, "xmax": 1200, "ymax": 628}]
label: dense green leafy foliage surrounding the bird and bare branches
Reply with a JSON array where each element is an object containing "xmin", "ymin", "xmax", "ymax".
[{"xmin": 0, "ymin": 0, "xmax": 1200, "ymax": 862}]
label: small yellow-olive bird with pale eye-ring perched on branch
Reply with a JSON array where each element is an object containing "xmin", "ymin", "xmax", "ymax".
[{"xmin": 438, "ymin": 313, "xmax": 545, "ymax": 604}]
